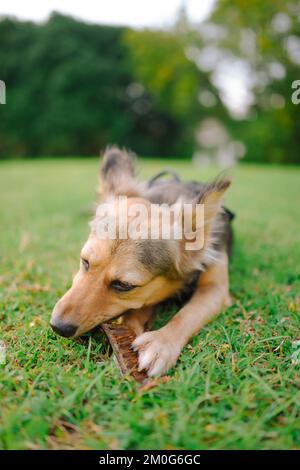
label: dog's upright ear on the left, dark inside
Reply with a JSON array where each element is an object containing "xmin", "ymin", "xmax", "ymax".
[{"xmin": 98, "ymin": 147, "xmax": 138, "ymax": 196}]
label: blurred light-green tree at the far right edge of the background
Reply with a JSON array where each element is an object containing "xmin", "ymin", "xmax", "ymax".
[{"xmin": 199, "ymin": 0, "xmax": 300, "ymax": 163}]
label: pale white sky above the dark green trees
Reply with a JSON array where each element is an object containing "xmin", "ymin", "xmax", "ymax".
[{"xmin": 0, "ymin": 0, "xmax": 215, "ymax": 27}]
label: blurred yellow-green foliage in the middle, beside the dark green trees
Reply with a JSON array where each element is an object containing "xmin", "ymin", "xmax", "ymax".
[{"xmin": 125, "ymin": 30, "xmax": 201, "ymax": 155}]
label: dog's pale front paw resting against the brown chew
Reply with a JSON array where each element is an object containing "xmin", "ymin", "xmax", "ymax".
[{"xmin": 132, "ymin": 330, "xmax": 181, "ymax": 377}]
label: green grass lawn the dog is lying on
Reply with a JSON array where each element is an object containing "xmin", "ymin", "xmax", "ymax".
[{"xmin": 0, "ymin": 156, "xmax": 300, "ymax": 449}]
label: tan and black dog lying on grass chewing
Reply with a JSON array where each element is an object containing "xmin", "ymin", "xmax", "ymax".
[{"xmin": 50, "ymin": 147, "xmax": 233, "ymax": 376}]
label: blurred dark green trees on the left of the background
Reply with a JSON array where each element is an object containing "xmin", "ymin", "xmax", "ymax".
[{"xmin": 0, "ymin": 14, "xmax": 200, "ymax": 157}]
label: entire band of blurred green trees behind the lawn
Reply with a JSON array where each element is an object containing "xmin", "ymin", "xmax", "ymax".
[{"xmin": 0, "ymin": 0, "xmax": 300, "ymax": 163}]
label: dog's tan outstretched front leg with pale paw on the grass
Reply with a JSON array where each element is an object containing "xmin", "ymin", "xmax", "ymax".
[{"xmin": 133, "ymin": 253, "xmax": 230, "ymax": 376}]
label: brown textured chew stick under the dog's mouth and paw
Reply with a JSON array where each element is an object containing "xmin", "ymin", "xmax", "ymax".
[{"xmin": 101, "ymin": 323, "xmax": 148, "ymax": 383}]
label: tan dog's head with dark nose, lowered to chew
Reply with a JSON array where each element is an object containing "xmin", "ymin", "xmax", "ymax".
[{"xmin": 51, "ymin": 149, "xmax": 228, "ymax": 337}]
